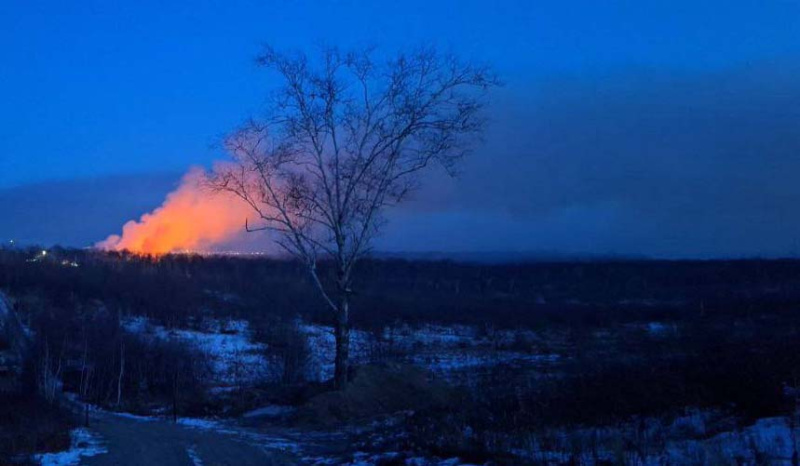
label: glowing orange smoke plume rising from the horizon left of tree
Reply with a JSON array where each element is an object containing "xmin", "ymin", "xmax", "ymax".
[{"xmin": 96, "ymin": 168, "xmax": 252, "ymax": 255}]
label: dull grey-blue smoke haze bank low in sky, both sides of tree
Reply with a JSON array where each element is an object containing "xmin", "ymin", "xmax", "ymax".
[{"xmin": 0, "ymin": 60, "xmax": 800, "ymax": 257}]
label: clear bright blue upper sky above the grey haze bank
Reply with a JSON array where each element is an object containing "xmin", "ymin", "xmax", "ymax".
[{"xmin": 0, "ymin": 0, "xmax": 800, "ymax": 187}]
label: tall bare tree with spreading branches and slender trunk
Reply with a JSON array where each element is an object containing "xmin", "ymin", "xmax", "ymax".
[{"xmin": 210, "ymin": 48, "xmax": 498, "ymax": 389}]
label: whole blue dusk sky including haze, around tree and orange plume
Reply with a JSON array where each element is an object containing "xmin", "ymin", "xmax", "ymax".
[{"xmin": 0, "ymin": 0, "xmax": 800, "ymax": 257}]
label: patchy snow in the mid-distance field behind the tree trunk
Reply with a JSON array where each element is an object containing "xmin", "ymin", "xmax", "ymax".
[{"xmin": 123, "ymin": 317, "xmax": 559, "ymax": 386}]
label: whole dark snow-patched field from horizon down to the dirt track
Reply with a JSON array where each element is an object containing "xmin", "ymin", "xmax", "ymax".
[{"xmin": 0, "ymin": 249, "xmax": 800, "ymax": 464}]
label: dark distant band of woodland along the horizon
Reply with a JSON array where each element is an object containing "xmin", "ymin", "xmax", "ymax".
[{"xmin": 0, "ymin": 248, "xmax": 800, "ymax": 327}]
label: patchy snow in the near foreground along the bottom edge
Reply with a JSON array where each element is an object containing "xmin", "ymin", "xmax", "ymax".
[{"xmin": 45, "ymin": 396, "xmax": 800, "ymax": 466}]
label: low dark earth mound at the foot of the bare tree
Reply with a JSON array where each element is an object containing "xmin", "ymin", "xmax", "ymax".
[{"xmin": 296, "ymin": 365, "xmax": 455, "ymax": 425}]
